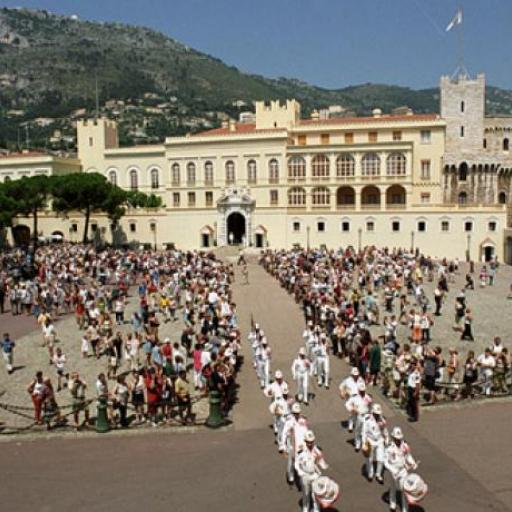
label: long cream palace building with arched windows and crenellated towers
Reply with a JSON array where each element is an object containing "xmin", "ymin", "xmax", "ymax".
[{"xmin": 0, "ymin": 75, "xmax": 512, "ymax": 261}]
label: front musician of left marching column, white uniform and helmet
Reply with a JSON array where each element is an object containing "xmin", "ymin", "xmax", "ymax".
[{"xmin": 295, "ymin": 430, "xmax": 328, "ymax": 512}]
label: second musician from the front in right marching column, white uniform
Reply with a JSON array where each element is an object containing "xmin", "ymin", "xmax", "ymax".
[{"xmin": 362, "ymin": 404, "xmax": 389, "ymax": 484}]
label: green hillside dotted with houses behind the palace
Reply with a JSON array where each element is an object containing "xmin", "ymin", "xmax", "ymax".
[{"xmin": 0, "ymin": 8, "xmax": 512, "ymax": 149}]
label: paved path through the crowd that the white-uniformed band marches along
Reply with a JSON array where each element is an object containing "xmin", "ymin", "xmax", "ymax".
[{"xmin": 233, "ymin": 264, "xmax": 507, "ymax": 512}]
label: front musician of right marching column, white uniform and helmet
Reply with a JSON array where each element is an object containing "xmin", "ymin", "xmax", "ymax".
[{"xmin": 384, "ymin": 427, "xmax": 418, "ymax": 512}]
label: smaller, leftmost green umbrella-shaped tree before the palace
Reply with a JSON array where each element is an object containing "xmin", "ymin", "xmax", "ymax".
[{"xmin": 3, "ymin": 176, "xmax": 55, "ymax": 246}]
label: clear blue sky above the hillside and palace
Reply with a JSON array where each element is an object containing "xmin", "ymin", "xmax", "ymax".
[{"xmin": 4, "ymin": 0, "xmax": 512, "ymax": 89}]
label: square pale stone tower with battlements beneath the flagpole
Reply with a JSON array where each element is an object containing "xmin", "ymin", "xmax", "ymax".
[{"xmin": 440, "ymin": 74, "xmax": 485, "ymax": 161}]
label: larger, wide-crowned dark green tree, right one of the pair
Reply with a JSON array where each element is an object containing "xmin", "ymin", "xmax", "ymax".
[{"xmin": 53, "ymin": 173, "xmax": 126, "ymax": 243}]
